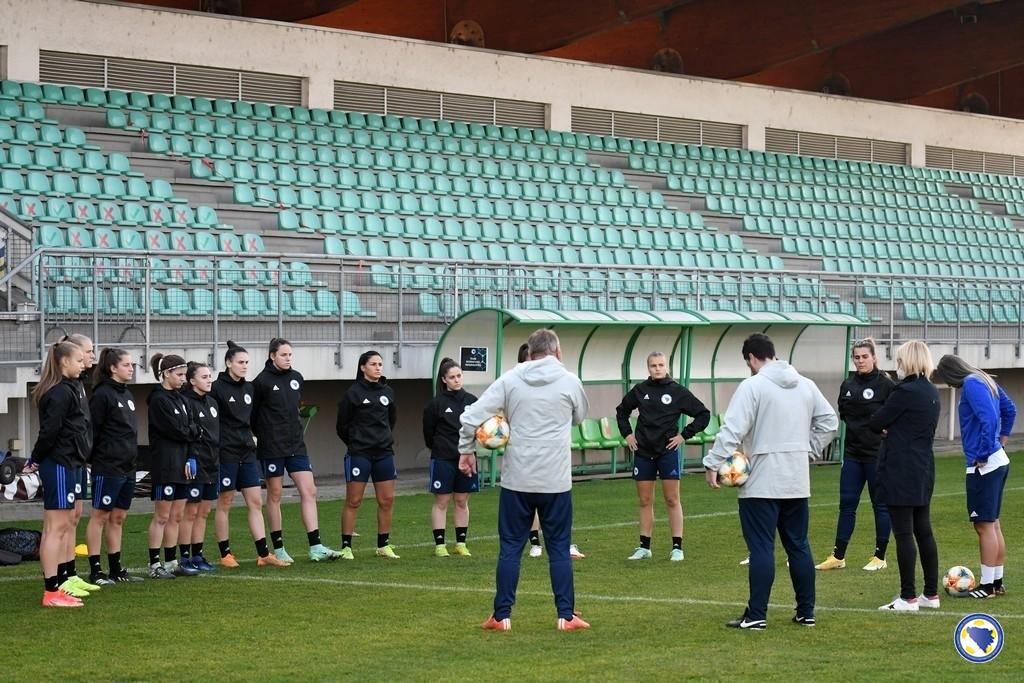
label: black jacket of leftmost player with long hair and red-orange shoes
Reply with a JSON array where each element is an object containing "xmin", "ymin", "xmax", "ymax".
[{"xmin": 32, "ymin": 379, "xmax": 92, "ymax": 468}]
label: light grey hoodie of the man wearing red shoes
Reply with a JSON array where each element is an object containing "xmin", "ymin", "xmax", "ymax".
[{"xmin": 459, "ymin": 355, "xmax": 590, "ymax": 494}]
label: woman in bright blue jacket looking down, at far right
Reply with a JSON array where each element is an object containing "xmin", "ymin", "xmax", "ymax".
[{"xmin": 935, "ymin": 355, "xmax": 1017, "ymax": 598}]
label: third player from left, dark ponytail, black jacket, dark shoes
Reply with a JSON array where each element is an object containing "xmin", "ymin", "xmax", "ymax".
[{"xmin": 85, "ymin": 347, "xmax": 142, "ymax": 586}]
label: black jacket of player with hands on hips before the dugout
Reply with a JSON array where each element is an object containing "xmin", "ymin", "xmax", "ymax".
[{"xmin": 615, "ymin": 377, "xmax": 711, "ymax": 459}]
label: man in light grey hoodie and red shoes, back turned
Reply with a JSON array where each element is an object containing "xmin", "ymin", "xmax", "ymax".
[{"xmin": 459, "ymin": 330, "xmax": 590, "ymax": 631}]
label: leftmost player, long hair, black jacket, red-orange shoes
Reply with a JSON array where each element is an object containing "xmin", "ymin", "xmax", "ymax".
[{"xmin": 31, "ymin": 342, "xmax": 92, "ymax": 607}]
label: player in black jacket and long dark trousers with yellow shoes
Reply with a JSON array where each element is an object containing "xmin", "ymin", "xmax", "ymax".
[{"xmin": 814, "ymin": 339, "xmax": 896, "ymax": 571}]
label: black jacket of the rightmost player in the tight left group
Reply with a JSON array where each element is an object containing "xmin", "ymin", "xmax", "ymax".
[{"xmin": 250, "ymin": 360, "xmax": 306, "ymax": 460}]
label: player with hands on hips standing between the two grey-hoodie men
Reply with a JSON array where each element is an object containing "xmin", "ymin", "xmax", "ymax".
[{"xmin": 615, "ymin": 351, "xmax": 711, "ymax": 562}]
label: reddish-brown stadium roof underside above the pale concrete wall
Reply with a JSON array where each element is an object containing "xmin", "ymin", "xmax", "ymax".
[{"xmin": 117, "ymin": 0, "xmax": 1024, "ymax": 118}]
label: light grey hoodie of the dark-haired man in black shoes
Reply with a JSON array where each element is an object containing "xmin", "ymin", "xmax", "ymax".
[{"xmin": 703, "ymin": 360, "xmax": 839, "ymax": 498}]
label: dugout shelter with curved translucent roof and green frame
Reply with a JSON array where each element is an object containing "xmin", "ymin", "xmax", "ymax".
[{"xmin": 434, "ymin": 308, "xmax": 868, "ymax": 484}]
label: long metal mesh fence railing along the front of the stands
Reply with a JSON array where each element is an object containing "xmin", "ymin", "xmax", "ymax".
[{"xmin": 0, "ymin": 249, "xmax": 1024, "ymax": 364}]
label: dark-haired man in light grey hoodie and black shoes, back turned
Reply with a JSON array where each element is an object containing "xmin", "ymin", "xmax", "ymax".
[{"xmin": 703, "ymin": 334, "xmax": 839, "ymax": 631}]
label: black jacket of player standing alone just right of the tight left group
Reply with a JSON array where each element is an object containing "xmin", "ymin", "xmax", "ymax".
[{"xmin": 337, "ymin": 377, "xmax": 398, "ymax": 458}]
